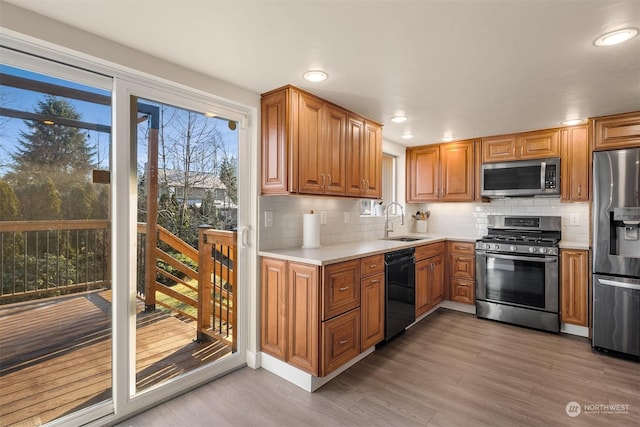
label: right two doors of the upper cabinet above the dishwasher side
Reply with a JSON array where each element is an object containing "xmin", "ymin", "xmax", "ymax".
[{"xmin": 346, "ymin": 114, "xmax": 382, "ymax": 199}]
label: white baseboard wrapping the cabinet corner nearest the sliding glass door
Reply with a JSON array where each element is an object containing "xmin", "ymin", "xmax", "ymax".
[{"xmin": 260, "ymin": 347, "xmax": 375, "ymax": 392}]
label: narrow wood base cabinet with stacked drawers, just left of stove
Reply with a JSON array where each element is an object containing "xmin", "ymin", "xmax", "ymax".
[{"xmin": 447, "ymin": 241, "xmax": 476, "ymax": 304}]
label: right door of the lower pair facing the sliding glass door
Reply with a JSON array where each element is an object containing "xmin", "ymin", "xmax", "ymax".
[{"xmin": 287, "ymin": 262, "xmax": 319, "ymax": 375}]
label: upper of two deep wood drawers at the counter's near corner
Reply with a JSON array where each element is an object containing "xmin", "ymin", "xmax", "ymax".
[{"xmin": 322, "ymin": 259, "xmax": 360, "ymax": 320}]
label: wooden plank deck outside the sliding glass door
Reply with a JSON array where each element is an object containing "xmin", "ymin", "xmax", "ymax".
[{"xmin": 0, "ymin": 291, "xmax": 230, "ymax": 426}]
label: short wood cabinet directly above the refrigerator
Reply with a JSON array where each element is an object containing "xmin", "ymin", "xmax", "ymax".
[{"xmin": 591, "ymin": 111, "xmax": 640, "ymax": 150}]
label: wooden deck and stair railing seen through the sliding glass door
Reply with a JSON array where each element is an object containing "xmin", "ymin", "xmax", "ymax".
[{"xmin": 0, "ymin": 220, "xmax": 237, "ymax": 349}]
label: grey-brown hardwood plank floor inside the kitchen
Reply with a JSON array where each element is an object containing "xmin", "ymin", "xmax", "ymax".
[{"xmin": 119, "ymin": 309, "xmax": 640, "ymax": 427}]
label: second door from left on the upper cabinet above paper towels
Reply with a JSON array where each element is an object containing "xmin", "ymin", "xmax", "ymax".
[{"xmin": 318, "ymin": 105, "xmax": 347, "ymax": 196}]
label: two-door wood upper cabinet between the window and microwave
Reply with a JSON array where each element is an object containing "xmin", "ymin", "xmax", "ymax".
[{"xmin": 406, "ymin": 141, "xmax": 476, "ymax": 203}]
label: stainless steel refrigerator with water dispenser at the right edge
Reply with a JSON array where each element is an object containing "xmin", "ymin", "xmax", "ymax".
[{"xmin": 592, "ymin": 148, "xmax": 640, "ymax": 357}]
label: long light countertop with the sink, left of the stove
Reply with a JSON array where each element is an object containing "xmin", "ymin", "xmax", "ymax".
[{"xmin": 258, "ymin": 233, "xmax": 476, "ymax": 265}]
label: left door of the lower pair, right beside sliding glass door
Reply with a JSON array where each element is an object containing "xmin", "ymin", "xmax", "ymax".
[{"xmin": 260, "ymin": 258, "xmax": 287, "ymax": 360}]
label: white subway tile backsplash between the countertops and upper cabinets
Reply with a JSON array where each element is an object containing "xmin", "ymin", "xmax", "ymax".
[{"xmin": 259, "ymin": 196, "xmax": 590, "ymax": 250}]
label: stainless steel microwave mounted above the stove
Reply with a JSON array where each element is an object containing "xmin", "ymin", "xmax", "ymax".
[{"xmin": 480, "ymin": 158, "xmax": 560, "ymax": 197}]
